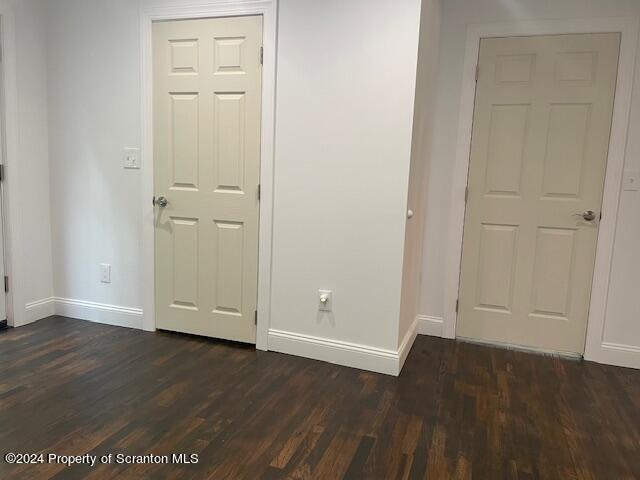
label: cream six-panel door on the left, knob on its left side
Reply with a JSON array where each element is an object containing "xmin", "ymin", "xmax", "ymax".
[{"xmin": 150, "ymin": 16, "xmax": 262, "ymax": 343}]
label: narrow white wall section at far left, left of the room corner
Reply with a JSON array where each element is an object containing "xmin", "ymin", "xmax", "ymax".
[{"xmin": 0, "ymin": 0, "xmax": 53, "ymax": 326}]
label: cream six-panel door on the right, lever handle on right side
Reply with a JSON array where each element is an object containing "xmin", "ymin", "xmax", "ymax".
[{"xmin": 457, "ymin": 34, "xmax": 620, "ymax": 354}]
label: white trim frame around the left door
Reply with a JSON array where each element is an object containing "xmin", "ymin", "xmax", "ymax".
[{"xmin": 140, "ymin": 0, "xmax": 278, "ymax": 350}]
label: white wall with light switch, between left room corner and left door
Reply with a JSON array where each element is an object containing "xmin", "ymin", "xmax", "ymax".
[{"xmin": 46, "ymin": 0, "xmax": 142, "ymax": 307}]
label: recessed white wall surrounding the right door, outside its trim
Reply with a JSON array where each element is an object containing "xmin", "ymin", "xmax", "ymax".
[{"xmin": 420, "ymin": 0, "xmax": 640, "ymax": 352}]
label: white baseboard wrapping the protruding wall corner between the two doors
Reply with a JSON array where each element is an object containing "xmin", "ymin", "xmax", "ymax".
[{"xmin": 269, "ymin": 323, "xmax": 416, "ymax": 376}]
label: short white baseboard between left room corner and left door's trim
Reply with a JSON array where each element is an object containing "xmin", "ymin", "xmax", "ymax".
[{"xmin": 54, "ymin": 297, "xmax": 142, "ymax": 330}]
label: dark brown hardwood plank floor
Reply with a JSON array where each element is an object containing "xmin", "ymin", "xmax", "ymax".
[{"xmin": 0, "ymin": 317, "xmax": 640, "ymax": 480}]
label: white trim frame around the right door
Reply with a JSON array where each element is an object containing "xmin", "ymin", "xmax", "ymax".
[{"xmin": 443, "ymin": 18, "xmax": 638, "ymax": 363}]
